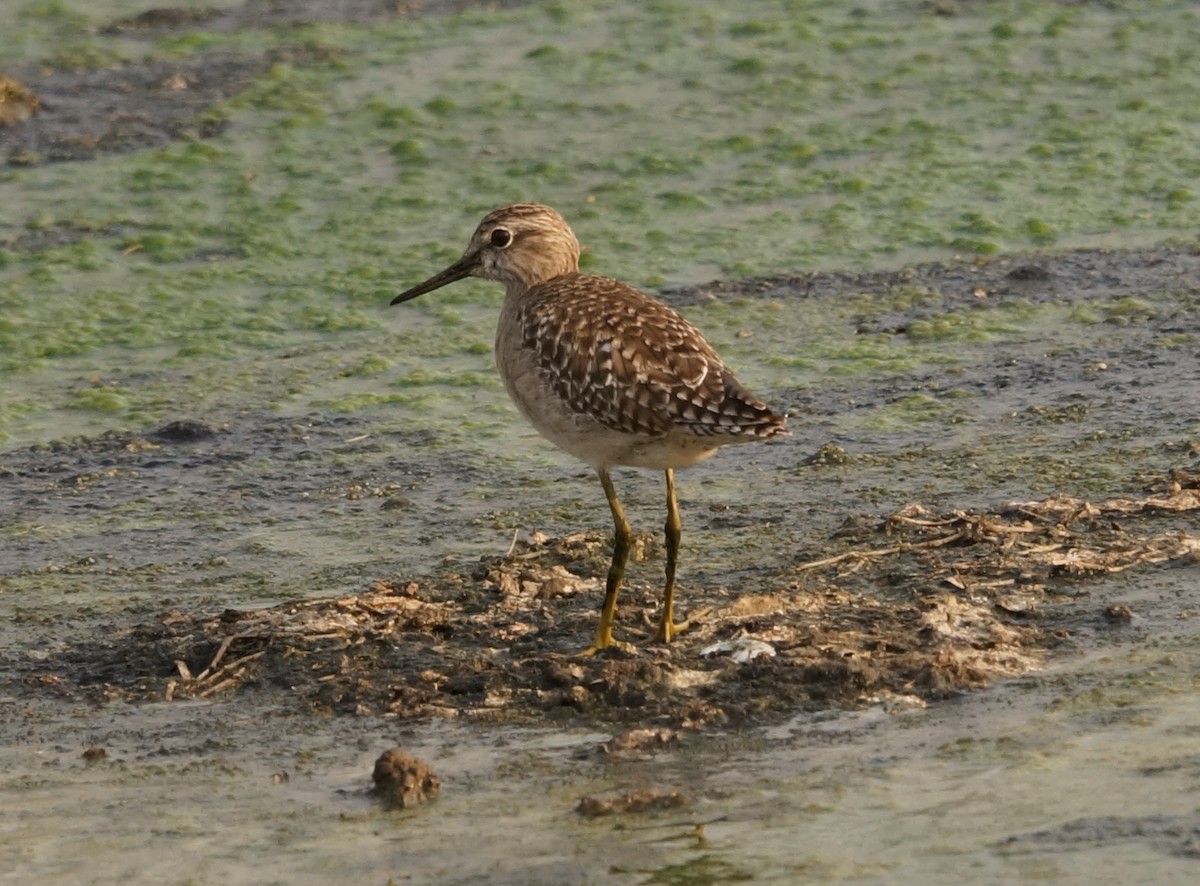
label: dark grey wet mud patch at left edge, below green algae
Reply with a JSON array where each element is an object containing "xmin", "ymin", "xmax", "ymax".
[{"xmin": 0, "ymin": 414, "xmax": 463, "ymax": 576}]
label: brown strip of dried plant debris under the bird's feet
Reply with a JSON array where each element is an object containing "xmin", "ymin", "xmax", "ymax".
[{"xmin": 25, "ymin": 474, "xmax": 1200, "ymax": 720}]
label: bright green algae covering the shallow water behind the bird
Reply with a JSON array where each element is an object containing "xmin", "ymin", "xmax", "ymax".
[{"xmin": 0, "ymin": 1, "xmax": 1200, "ymax": 449}]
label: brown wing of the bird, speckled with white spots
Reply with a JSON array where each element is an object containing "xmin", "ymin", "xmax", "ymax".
[{"xmin": 521, "ymin": 268, "xmax": 786, "ymax": 437}]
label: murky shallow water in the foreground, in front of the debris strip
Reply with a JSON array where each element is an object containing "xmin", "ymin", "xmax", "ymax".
[{"xmin": 0, "ymin": 624, "xmax": 1200, "ymax": 884}]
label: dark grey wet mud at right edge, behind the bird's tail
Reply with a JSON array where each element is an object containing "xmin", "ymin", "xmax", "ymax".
[{"xmin": 664, "ymin": 247, "xmax": 1200, "ymax": 458}]
